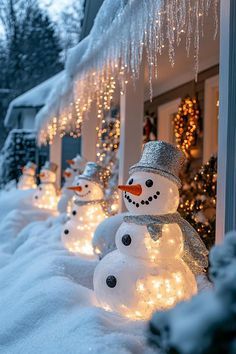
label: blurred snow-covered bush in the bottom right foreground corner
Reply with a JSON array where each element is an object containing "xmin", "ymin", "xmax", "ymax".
[{"xmin": 149, "ymin": 232, "xmax": 236, "ymax": 354}]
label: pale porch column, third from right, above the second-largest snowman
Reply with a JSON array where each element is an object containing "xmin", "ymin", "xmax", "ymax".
[{"xmin": 81, "ymin": 102, "xmax": 97, "ymax": 162}]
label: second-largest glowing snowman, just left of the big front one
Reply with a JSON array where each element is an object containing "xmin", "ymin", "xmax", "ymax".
[{"xmin": 61, "ymin": 162, "xmax": 109, "ymax": 256}]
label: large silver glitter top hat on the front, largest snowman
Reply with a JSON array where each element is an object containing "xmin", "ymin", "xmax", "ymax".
[{"xmin": 129, "ymin": 141, "xmax": 185, "ymax": 187}]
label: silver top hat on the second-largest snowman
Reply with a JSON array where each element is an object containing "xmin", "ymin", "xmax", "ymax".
[{"xmin": 78, "ymin": 162, "xmax": 110, "ymax": 188}]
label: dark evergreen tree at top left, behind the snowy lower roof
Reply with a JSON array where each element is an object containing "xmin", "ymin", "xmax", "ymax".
[{"xmin": 0, "ymin": 0, "xmax": 63, "ymax": 99}]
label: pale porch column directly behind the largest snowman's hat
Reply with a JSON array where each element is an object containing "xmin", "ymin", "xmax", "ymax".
[{"xmin": 119, "ymin": 70, "xmax": 144, "ymax": 211}]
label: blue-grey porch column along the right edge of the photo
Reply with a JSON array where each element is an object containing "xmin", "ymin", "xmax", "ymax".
[{"xmin": 216, "ymin": 0, "xmax": 236, "ymax": 243}]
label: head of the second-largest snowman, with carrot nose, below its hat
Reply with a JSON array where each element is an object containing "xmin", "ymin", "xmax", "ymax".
[{"xmin": 68, "ymin": 176, "xmax": 104, "ymax": 201}]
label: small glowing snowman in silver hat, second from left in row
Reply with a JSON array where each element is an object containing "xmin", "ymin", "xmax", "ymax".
[{"xmin": 33, "ymin": 161, "xmax": 58, "ymax": 210}]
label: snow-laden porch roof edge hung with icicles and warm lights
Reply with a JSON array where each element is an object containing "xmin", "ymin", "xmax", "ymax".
[{"xmin": 38, "ymin": 0, "xmax": 219, "ymax": 145}]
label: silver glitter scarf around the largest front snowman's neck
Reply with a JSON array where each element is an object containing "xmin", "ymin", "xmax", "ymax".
[{"xmin": 124, "ymin": 212, "xmax": 208, "ymax": 274}]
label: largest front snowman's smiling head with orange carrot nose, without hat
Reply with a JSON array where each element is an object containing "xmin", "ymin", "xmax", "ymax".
[{"xmin": 119, "ymin": 171, "xmax": 179, "ymax": 215}]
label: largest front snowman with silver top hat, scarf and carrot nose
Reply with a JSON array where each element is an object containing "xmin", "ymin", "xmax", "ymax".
[{"xmin": 94, "ymin": 141, "xmax": 208, "ymax": 319}]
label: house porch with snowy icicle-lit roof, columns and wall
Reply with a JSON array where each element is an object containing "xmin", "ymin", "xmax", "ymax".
[{"xmin": 7, "ymin": 1, "xmax": 236, "ymax": 246}]
